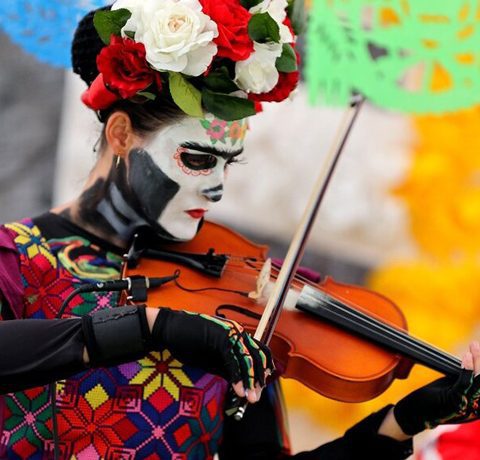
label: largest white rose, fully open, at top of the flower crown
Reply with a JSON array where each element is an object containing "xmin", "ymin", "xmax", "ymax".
[{"xmin": 115, "ymin": 0, "xmax": 218, "ymax": 76}]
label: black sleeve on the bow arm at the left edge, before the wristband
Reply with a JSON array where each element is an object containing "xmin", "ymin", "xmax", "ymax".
[{"xmin": 0, "ymin": 318, "xmax": 86, "ymax": 394}]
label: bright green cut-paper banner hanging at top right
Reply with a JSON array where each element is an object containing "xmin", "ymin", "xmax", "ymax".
[{"xmin": 306, "ymin": 0, "xmax": 480, "ymax": 113}]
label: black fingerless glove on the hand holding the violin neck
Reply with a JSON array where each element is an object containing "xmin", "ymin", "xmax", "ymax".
[{"xmin": 393, "ymin": 369, "xmax": 480, "ymax": 436}]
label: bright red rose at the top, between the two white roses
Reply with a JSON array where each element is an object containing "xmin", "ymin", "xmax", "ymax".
[{"xmin": 200, "ymin": 0, "xmax": 253, "ymax": 62}]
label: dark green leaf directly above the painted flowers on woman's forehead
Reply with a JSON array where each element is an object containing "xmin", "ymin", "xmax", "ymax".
[{"xmin": 202, "ymin": 89, "xmax": 256, "ymax": 121}]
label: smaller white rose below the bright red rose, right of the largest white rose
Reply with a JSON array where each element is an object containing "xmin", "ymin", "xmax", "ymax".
[{"xmin": 235, "ymin": 43, "xmax": 282, "ymax": 94}]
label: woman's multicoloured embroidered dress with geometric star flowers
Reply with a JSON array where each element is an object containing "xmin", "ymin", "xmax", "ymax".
[{"xmin": 0, "ymin": 217, "xmax": 226, "ymax": 460}]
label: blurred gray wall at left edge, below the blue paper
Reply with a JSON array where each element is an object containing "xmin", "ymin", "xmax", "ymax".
[{"xmin": 0, "ymin": 33, "xmax": 64, "ymax": 222}]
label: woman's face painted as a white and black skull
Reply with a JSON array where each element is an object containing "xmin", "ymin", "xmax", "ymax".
[{"xmin": 128, "ymin": 116, "xmax": 247, "ymax": 240}]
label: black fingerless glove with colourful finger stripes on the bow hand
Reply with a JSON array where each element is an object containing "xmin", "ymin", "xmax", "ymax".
[{"xmin": 152, "ymin": 308, "xmax": 273, "ymax": 389}]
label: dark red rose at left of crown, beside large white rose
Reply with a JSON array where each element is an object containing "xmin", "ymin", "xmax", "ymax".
[{"xmin": 97, "ymin": 35, "xmax": 161, "ymax": 99}]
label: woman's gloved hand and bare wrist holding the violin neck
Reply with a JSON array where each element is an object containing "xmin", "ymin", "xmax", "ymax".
[{"xmin": 379, "ymin": 342, "xmax": 480, "ymax": 439}]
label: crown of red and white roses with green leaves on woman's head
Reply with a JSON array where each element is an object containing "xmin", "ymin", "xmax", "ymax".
[{"xmin": 82, "ymin": 0, "xmax": 301, "ymax": 121}]
